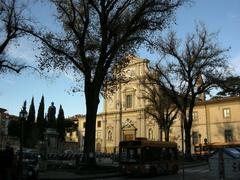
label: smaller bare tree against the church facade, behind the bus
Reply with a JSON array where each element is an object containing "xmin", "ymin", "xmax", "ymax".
[{"xmin": 139, "ymin": 75, "xmax": 178, "ymax": 141}]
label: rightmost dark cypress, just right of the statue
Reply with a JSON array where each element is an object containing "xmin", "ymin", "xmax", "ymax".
[{"xmin": 57, "ymin": 105, "xmax": 65, "ymax": 142}]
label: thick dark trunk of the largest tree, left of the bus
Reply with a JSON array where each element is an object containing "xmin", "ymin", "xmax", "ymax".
[{"xmin": 83, "ymin": 82, "xmax": 99, "ymax": 165}]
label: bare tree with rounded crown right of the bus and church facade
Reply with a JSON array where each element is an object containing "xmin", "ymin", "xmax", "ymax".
[{"xmin": 154, "ymin": 25, "xmax": 228, "ymax": 158}]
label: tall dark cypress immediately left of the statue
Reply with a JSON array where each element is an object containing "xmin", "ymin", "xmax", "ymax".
[{"xmin": 37, "ymin": 96, "xmax": 46, "ymax": 140}]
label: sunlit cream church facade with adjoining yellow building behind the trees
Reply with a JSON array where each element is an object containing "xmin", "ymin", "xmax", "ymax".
[{"xmin": 68, "ymin": 56, "xmax": 240, "ymax": 153}]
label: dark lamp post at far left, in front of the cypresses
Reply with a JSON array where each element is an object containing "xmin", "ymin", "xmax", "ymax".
[{"xmin": 19, "ymin": 101, "xmax": 27, "ymax": 178}]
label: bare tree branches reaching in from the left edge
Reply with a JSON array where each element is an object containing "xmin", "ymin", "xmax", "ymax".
[{"xmin": 0, "ymin": 0, "xmax": 29, "ymax": 74}]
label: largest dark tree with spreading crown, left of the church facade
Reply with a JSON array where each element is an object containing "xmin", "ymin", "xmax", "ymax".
[{"xmin": 24, "ymin": 0, "xmax": 185, "ymax": 164}]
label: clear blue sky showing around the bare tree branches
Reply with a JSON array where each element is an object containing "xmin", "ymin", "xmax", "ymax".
[{"xmin": 0, "ymin": 0, "xmax": 240, "ymax": 116}]
